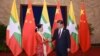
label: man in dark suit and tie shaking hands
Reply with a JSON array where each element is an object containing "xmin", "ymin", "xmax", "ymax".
[{"xmin": 53, "ymin": 20, "xmax": 70, "ymax": 56}]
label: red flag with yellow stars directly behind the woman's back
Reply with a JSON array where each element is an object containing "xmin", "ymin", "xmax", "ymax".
[{"xmin": 22, "ymin": 0, "xmax": 35, "ymax": 56}]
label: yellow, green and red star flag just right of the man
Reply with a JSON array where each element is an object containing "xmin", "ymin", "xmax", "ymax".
[{"xmin": 67, "ymin": 1, "xmax": 78, "ymax": 53}]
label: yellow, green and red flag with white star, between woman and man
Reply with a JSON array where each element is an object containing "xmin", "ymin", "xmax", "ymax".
[{"xmin": 40, "ymin": 0, "xmax": 52, "ymax": 54}]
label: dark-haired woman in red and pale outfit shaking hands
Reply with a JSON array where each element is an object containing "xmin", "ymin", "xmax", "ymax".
[{"xmin": 35, "ymin": 24, "xmax": 47, "ymax": 56}]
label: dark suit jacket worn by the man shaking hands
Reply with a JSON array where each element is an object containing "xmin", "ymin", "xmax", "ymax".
[{"xmin": 53, "ymin": 28, "xmax": 70, "ymax": 50}]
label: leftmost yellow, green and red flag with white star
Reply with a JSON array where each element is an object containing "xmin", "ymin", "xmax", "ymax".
[{"xmin": 6, "ymin": 0, "xmax": 22, "ymax": 56}]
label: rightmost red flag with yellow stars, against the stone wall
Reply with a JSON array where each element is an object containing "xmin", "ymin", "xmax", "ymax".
[{"xmin": 79, "ymin": 4, "xmax": 91, "ymax": 52}]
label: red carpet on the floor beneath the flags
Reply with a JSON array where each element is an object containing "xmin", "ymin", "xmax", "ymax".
[{"xmin": 0, "ymin": 47, "xmax": 100, "ymax": 56}]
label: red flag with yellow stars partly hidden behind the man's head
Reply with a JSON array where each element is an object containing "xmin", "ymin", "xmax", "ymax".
[{"xmin": 52, "ymin": 1, "xmax": 63, "ymax": 34}]
